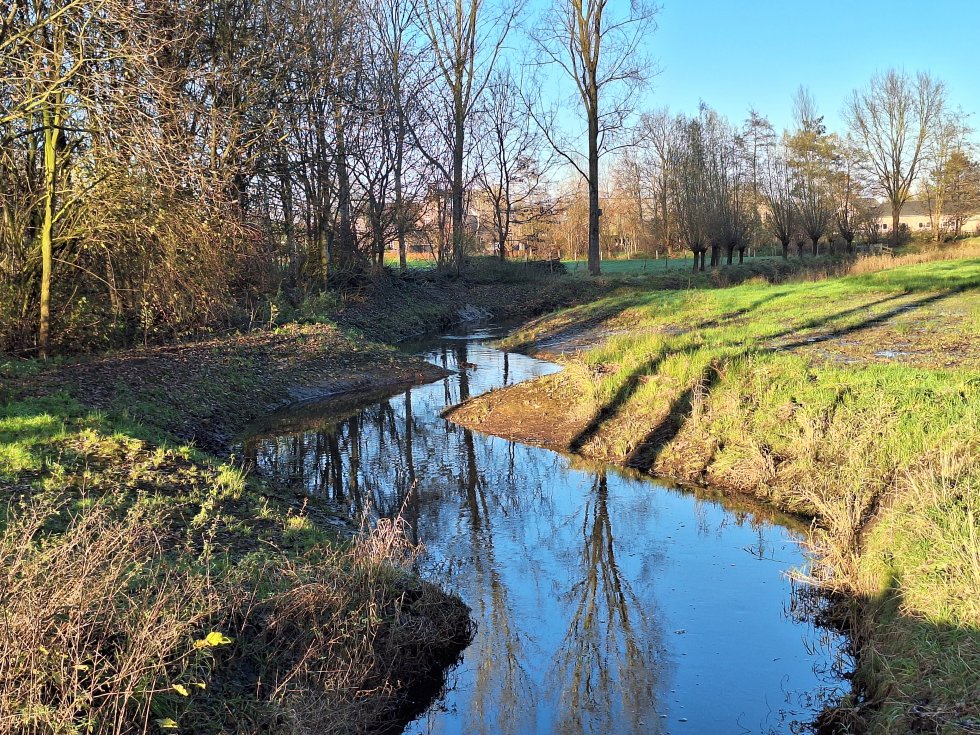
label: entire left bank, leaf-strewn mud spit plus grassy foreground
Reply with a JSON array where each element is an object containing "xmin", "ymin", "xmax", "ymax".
[{"xmin": 0, "ymin": 326, "xmax": 470, "ymax": 734}]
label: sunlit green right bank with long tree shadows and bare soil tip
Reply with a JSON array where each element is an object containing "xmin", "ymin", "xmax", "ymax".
[{"xmin": 451, "ymin": 258, "xmax": 980, "ymax": 733}]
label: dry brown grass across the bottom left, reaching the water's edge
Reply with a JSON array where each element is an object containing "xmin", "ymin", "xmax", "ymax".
[{"xmin": 0, "ymin": 504, "xmax": 471, "ymax": 735}]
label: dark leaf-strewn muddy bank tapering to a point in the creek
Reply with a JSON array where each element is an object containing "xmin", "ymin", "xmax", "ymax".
[{"xmin": 10, "ymin": 324, "xmax": 444, "ymax": 456}]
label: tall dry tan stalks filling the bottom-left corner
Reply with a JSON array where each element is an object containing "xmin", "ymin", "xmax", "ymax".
[{"xmin": 0, "ymin": 505, "xmax": 223, "ymax": 734}]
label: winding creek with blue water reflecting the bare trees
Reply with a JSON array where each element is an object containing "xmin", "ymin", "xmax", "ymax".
[{"xmin": 241, "ymin": 330, "xmax": 848, "ymax": 735}]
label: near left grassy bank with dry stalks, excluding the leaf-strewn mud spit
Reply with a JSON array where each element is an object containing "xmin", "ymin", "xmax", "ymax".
[{"xmin": 0, "ymin": 386, "xmax": 469, "ymax": 735}]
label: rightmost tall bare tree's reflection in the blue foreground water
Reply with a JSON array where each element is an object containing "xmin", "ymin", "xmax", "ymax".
[{"xmin": 552, "ymin": 471, "xmax": 662, "ymax": 733}]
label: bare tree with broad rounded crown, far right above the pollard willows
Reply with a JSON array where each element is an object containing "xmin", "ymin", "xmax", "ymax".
[{"xmin": 844, "ymin": 69, "xmax": 946, "ymax": 243}]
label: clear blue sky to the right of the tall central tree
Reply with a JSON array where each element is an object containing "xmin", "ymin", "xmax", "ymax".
[{"xmin": 644, "ymin": 0, "xmax": 980, "ymax": 135}]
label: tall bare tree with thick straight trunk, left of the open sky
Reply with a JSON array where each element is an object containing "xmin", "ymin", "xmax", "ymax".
[{"xmin": 533, "ymin": 0, "xmax": 657, "ymax": 275}]
